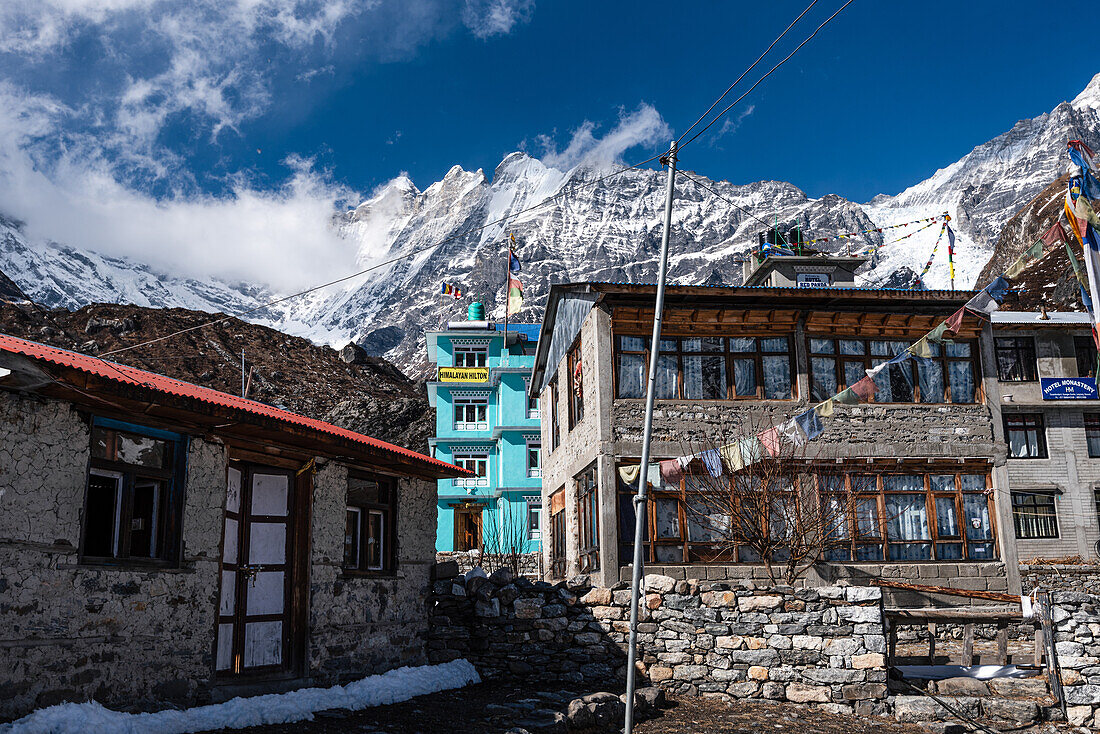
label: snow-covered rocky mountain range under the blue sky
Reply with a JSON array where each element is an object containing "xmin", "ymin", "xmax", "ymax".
[{"xmin": 0, "ymin": 75, "xmax": 1100, "ymax": 374}]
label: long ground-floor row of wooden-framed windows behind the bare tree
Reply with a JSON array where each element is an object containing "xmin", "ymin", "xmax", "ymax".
[{"xmin": 618, "ymin": 469, "xmax": 997, "ymax": 563}]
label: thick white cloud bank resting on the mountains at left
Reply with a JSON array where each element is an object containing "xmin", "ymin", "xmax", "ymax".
[{"xmin": 0, "ymin": 86, "xmax": 359, "ymax": 291}]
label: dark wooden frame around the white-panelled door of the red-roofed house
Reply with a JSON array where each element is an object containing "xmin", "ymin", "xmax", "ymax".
[{"xmin": 212, "ymin": 456, "xmax": 314, "ymax": 683}]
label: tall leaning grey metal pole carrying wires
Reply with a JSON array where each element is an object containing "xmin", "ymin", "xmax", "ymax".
[{"xmin": 624, "ymin": 141, "xmax": 677, "ymax": 734}]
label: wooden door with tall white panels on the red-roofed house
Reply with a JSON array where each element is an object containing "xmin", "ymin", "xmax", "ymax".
[{"xmin": 217, "ymin": 462, "xmax": 294, "ymax": 676}]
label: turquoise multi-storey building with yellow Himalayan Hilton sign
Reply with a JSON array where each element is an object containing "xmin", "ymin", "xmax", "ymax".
[{"xmin": 426, "ymin": 312, "xmax": 542, "ymax": 554}]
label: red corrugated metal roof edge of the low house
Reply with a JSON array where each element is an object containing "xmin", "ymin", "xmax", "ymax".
[{"xmin": 0, "ymin": 333, "xmax": 465, "ymax": 474}]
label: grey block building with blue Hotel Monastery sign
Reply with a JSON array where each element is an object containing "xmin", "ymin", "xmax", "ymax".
[{"xmin": 990, "ymin": 311, "xmax": 1100, "ymax": 562}]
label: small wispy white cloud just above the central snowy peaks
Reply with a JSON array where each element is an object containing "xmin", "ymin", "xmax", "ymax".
[{"xmin": 535, "ymin": 103, "xmax": 672, "ymax": 171}]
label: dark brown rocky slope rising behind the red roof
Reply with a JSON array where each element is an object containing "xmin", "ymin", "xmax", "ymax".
[{"xmin": 0, "ymin": 304, "xmax": 435, "ymax": 451}]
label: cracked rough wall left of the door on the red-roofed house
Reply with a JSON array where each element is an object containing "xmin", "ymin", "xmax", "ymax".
[{"xmin": 0, "ymin": 393, "xmax": 226, "ymax": 720}]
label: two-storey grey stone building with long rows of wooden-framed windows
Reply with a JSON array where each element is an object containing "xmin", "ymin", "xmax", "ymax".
[{"xmin": 531, "ymin": 272, "xmax": 1019, "ymax": 591}]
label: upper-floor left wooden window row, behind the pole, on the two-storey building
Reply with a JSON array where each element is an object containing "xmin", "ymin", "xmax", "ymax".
[{"xmin": 612, "ymin": 332, "xmax": 799, "ymax": 401}]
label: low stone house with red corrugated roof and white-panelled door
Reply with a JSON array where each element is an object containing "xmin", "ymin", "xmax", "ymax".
[{"xmin": 0, "ymin": 336, "xmax": 463, "ymax": 720}]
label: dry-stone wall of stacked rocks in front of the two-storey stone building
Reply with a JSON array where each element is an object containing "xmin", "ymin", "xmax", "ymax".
[{"xmin": 429, "ymin": 567, "xmax": 887, "ymax": 714}]
